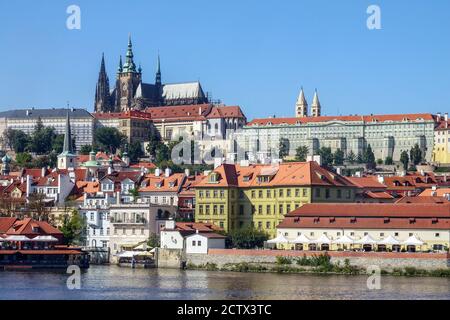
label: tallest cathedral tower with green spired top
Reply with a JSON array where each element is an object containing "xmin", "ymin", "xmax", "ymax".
[{"xmin": 115, "ymin": 36, "xmax": 142, "ymax": 112}]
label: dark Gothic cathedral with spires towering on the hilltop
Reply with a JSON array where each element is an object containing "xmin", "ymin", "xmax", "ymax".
[{"xmin": 94, "ymin": 37, "xmax": 209, "ymax": 113}]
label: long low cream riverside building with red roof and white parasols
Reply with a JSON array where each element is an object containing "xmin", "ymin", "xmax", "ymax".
[{"xmin": 276, "ymin": 203, "xmax": 450, "ymax": 251}]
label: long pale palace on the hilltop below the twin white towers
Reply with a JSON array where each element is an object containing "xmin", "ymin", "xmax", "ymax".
[{"xmin": 237, "ymin": 113, "xmax": 437, "ymax": 161}]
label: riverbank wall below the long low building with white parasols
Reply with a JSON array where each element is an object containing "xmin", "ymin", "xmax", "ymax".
[{"xmin": 185, "ymin": 249, "xmax": 450, "ymax": 271}]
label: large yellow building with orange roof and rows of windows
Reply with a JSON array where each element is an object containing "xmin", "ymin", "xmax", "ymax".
[{"xmin": 195, "ymin": 162, "xmax": 356, "ymax": 236}]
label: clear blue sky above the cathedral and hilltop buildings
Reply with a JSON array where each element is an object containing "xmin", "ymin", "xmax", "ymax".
[{"xmin": 0, "ymin": 0, "xmax": 450, "ymax": 119}]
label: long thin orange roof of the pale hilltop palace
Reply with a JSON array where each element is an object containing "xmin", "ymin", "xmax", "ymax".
[{"xmin": 248, "ymin": 113, "xmax": 434, "ymax": 126}]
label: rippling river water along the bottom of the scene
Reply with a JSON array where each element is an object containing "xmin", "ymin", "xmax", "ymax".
[{"xmin": 0, "ymin": 266, "xmax": 450, "ymax": 300}]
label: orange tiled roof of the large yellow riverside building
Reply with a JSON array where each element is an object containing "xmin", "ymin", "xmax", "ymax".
[{"xmin": 197, "ymin": 161, "xmax": 355, "ymax": 188}]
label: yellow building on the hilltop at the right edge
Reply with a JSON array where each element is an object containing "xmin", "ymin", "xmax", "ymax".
[{"xmin": 432, "ymin": 114, "xmax": 450, "ymax": 164}]
